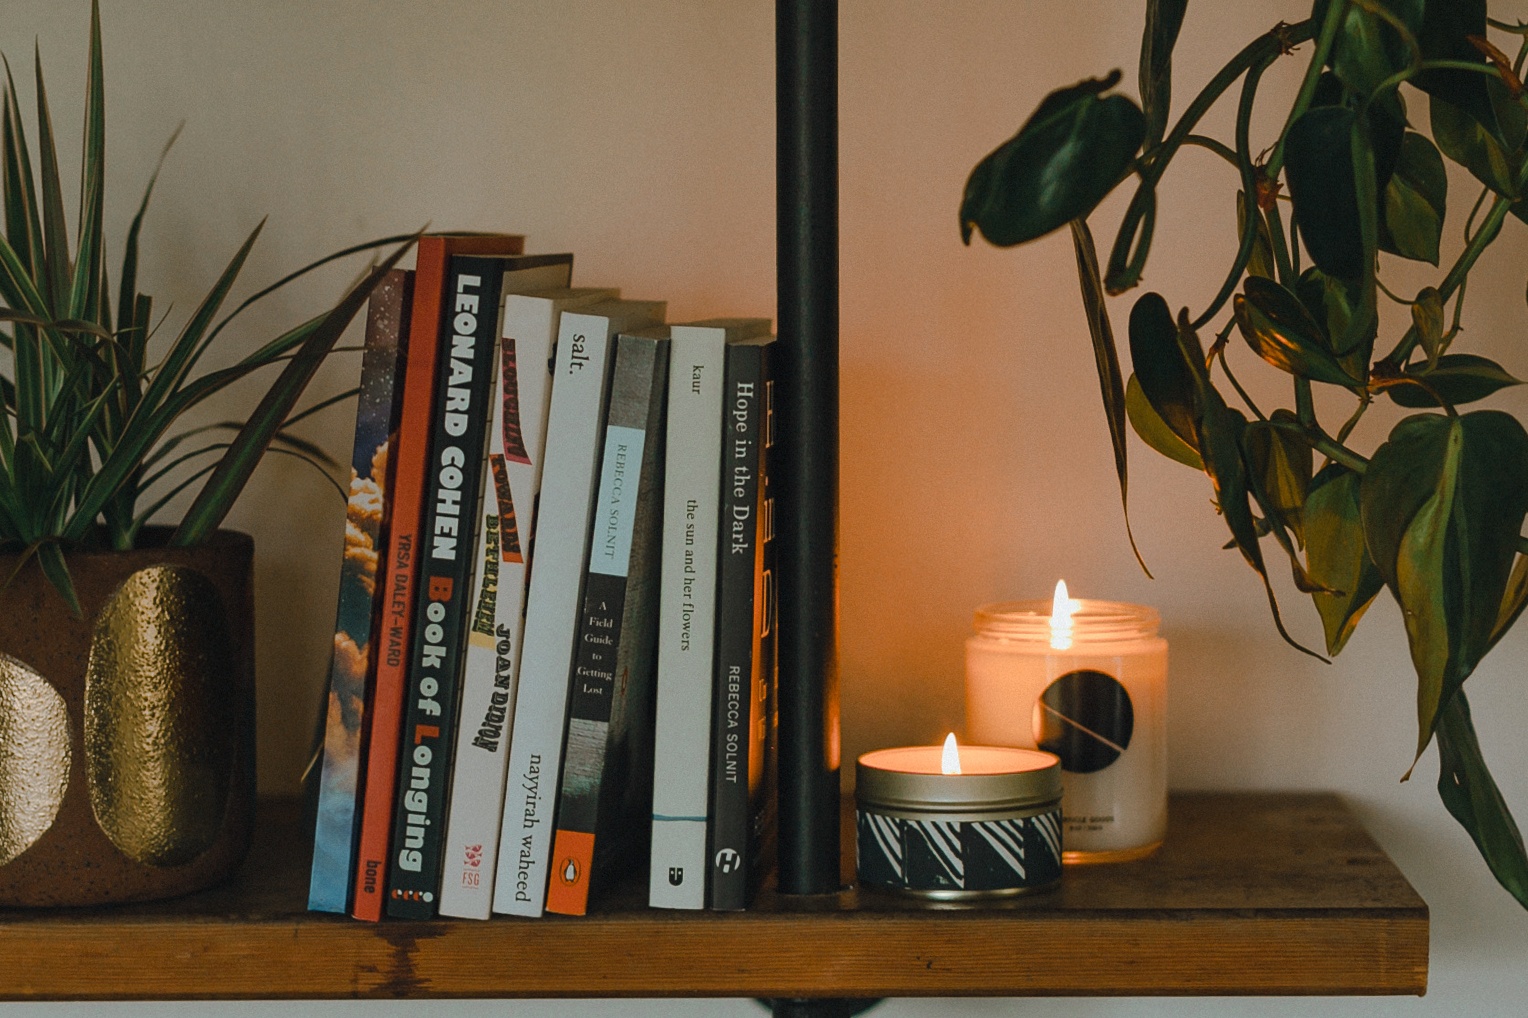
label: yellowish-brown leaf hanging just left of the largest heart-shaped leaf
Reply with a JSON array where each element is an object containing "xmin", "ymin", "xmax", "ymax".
[{"xmin": 1302, "ymin": 463, "xmax": 1384, "ymax": 656}]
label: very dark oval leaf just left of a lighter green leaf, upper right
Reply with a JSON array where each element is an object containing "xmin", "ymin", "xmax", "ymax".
[{"xmin": 1284, "ymin": 105, "xmax": 1363, "ymax": 278}]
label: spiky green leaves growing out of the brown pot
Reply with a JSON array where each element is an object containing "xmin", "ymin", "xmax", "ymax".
[{"xmin": 0, "ymin": 2, "xmax": 414, "ymax": 611}]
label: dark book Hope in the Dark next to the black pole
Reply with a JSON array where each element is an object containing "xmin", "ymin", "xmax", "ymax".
[{"xmin": 709, "ymin": 336, "xmax": 776, "ymax": 909}]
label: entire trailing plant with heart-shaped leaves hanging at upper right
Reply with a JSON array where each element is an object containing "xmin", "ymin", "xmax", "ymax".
[{"xmin": 960, "ymin": 0, "xmax": 1528, "ymax": 906}]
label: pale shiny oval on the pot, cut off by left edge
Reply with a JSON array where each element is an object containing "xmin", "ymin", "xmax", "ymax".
[{"xmin": 0, "ymin": 654, "xmax": 69, "ymax": 867}]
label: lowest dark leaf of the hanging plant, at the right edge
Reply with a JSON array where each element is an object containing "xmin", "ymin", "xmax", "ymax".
[{"xmin": 1438, "ymin": 691, "xmax": 1528, "ymax": 906}]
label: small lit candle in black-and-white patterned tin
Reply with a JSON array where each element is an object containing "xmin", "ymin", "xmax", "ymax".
[{"xmin": 854, "ymin": 732, "xmax": 1060, "ymax": 900}]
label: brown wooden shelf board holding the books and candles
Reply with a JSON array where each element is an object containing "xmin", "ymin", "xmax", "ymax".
[{"xmin": 0, "ymin": 793, "xmax": 1427, "ymax": 1000}]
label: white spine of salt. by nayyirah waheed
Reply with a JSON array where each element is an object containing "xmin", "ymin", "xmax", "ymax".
[{"xmin": 494, "ymin": 313, "xmax": 623, "ymax": 916}]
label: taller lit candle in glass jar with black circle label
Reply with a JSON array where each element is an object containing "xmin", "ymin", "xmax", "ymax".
[{"xmin": 966, "ymin": 582, "xmax": 1167, "ymax": 862}]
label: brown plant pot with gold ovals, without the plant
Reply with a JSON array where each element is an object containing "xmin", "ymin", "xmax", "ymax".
[{"xmin": 0, "ymin": 532, "xmax": 255, "ymax": 906}]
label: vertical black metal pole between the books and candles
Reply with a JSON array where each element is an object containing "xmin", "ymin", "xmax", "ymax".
[{"xmin": 775, "ymin": 0, "xmax": 839, "ymax": 894}]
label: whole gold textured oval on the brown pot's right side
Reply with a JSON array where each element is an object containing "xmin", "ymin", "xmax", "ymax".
[{"xmin": 84, "ymin": 566, "xmax": 237, "ymax": 867}]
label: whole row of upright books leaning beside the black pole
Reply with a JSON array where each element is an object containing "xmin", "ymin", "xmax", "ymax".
[{"xmin": 309, "ymin": 235, "xmax": 775, "ymax": 920}]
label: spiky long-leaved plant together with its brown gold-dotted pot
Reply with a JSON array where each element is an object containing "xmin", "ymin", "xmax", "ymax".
[{"xmin": 0, "ymin": 3, "xmax": 413, "ymax": 905}]
